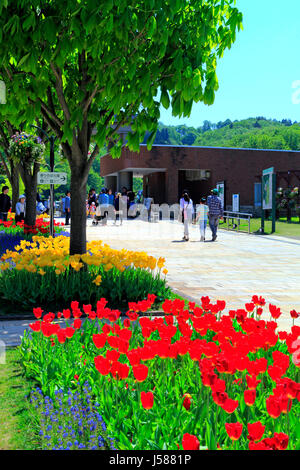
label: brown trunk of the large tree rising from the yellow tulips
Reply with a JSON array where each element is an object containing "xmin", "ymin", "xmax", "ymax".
[{"xmin": 70, "ymin": 164, "xmax": 87, "ymax": 255}]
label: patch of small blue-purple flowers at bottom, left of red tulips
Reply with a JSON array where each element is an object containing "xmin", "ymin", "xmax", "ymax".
[{"xmin": 30, "ymin": 383, "xmax": 113, "ymax": 450}]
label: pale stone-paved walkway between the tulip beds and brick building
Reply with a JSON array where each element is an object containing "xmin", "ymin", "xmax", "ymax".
[{"xmin": 0, "ymin": 220, "xmax": 300, "ymax": 346}]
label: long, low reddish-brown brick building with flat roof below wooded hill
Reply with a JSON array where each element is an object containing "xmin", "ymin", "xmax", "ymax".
[{"xmin": 101, "ymin": 144, "xmax": 300, "ymax": 210}]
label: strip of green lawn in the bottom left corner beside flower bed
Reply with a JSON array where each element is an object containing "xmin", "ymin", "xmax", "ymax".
[{"xmin": 0, "ymin": 349, "xmax": 40, "ymax": 450}]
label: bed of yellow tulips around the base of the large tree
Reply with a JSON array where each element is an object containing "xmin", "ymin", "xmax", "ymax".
[{"xmin": 0, "ymin": 236, "xmax": 170, "ymax": 308}]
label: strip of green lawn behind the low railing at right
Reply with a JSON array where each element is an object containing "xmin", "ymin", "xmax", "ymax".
[{"xmin": 219, "ymin": 217, "xmax": 300, "ymax": 239}]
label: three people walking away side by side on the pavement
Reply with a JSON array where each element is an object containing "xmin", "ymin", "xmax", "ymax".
[{"xmin": 180, "ymin": 189, "xmax": 223, "ymax": 242}]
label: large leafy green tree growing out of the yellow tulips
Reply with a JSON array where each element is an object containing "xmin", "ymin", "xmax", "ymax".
[{"xmin": 0, "ymin": 0, "xmax": 242, "ymax": 253}]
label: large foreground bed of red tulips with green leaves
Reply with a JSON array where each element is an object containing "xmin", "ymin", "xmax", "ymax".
[{"xmin": 20, "ymin": 295, "xmax": 300, "ymax": 450}]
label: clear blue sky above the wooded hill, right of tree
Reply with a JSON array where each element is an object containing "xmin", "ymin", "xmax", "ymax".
[{"xmin": 160, "ymin": 0, "xmax": 300, "ymax": 127}]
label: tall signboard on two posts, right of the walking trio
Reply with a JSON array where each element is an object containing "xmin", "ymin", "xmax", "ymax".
[{"xmin": 261, "ymin": 167, "xmax": 276, "ymax": 234}]
